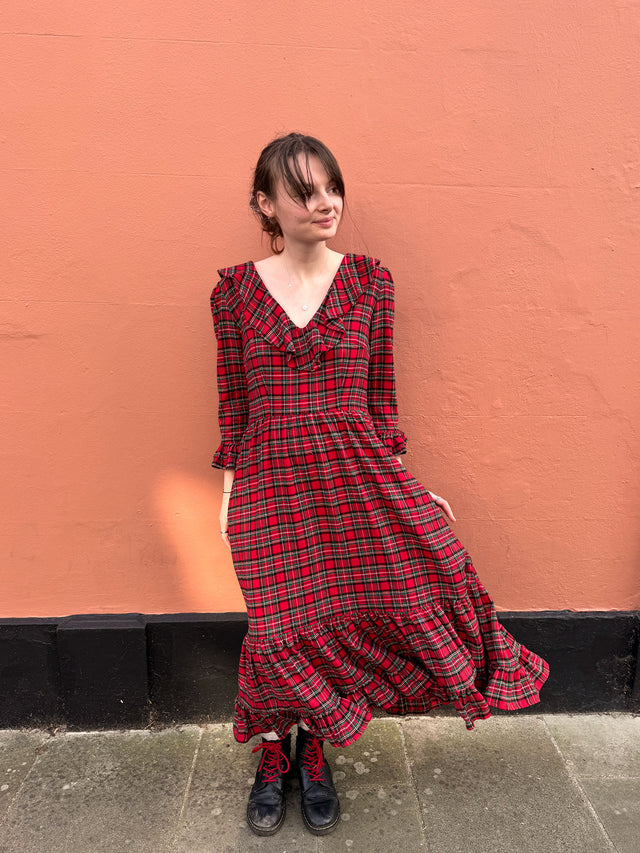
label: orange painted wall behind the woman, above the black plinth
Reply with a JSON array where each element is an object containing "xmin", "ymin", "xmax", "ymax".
[{"xmin": 0, "ymin": 0, "xmax": 640, "ymax": 617}]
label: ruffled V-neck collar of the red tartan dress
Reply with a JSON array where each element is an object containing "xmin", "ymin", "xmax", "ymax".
[{"xmin": 218, "ymin": 254, "xmax": 380, "ymax": 370}]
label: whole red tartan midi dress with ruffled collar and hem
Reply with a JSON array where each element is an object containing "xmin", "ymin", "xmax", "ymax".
[{"xmin": 211, "ymin": 254, "xmax": 549, "ymax": 746}]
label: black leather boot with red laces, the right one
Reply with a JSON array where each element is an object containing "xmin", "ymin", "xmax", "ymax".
[{"xmin": 296, "ymin": 726, "xmax": 340, "ymax": 835}]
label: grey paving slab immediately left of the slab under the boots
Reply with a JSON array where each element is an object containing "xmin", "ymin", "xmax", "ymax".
[{"xmin": 0, "ymin": 727, "xmax": 199, "ymax": 853}]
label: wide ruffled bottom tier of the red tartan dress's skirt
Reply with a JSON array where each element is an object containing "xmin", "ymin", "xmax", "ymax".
[{"xmin": 234, "ymin": 598, "xmax": 549, "ymax": 746}]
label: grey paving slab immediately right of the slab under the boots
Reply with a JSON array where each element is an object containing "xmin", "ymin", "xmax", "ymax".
[{"xmin": 403, "ymin": 717, "xmax": 612, "ymax": 853}]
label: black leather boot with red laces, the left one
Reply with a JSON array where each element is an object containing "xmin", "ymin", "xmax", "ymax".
[{"xmin": 247, "ymin": 732, "xmax": 291, "ymax": 835}]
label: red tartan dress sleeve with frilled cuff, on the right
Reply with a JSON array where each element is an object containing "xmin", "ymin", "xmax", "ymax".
[{"xmin": 367, "ymin": 267, "xmax": 407, "ymax": 456}]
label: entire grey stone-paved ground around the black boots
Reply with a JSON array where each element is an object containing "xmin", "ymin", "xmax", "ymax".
[{"xmin": 0, "ymin": 714, "xmax": 640, "ymax": 853}]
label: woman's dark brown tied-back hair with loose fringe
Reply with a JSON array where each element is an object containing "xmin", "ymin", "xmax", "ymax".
[{"xmin": 249, "ymin": 133, "xmax": 344, "ymax": 255}]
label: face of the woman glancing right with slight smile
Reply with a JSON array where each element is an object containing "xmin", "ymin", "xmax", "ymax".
[{"xmin": 256, "ymin": 156, "xmax": 344, "ymax": 244}]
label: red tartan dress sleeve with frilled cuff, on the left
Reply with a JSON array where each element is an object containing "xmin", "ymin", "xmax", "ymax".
[{"xmin": 211, "ymin": 282, "xmax": 249, "ymax": 468}]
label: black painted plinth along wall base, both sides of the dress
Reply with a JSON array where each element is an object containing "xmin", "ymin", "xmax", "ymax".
[{"xmin": 0, "ymin": 611, "xmax": 640, "ymax": 729}]
